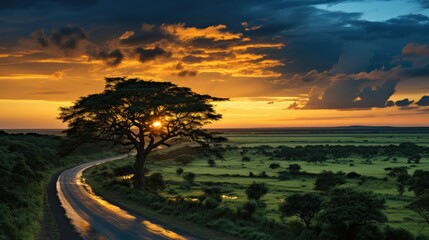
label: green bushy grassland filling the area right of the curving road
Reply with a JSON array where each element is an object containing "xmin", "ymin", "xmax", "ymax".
[{"xmin": 84, "ymin": 134, "xmax": 429, "ymax": 240}]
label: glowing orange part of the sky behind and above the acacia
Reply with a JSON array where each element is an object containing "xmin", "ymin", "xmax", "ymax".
[{"xmin": 0, "ymin": 24, "xmax": 429, "ymax": 129}]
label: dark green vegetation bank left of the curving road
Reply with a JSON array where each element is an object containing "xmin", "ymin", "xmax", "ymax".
[{"xmin": 0, "ymin": 131, "xmax": 120, "ymax": 240}]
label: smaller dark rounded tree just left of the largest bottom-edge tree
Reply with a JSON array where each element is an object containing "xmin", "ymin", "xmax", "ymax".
[{"xmin": 279, "ymin": 193, "xmax": 323, "ymax": 227}]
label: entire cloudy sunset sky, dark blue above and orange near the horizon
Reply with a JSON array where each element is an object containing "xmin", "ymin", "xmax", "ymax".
[{"xmin": 0, "ymin": 0, "xmax": 429, "ymax": 129}]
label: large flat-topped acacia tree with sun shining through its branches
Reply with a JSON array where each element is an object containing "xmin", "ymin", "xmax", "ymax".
[{"xmin": 59, "ymin": 77, "xmax": 228, "ymax": 189}]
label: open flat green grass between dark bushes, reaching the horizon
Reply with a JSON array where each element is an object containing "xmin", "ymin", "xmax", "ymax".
[{"xmin": 85, "ymin": 128, "xmax": 429, "ymax": 239}]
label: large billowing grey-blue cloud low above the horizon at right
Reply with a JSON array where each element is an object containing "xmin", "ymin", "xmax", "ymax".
[{"xmin": 304, "ymin": 79, "xmax": 398, "ymax": 109}]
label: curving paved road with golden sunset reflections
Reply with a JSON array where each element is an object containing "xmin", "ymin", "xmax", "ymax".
[{"xmin": 56, "ymin": 155, "xmax": 196, "ymax": 240}]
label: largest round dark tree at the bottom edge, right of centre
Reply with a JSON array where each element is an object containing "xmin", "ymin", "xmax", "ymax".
[{"xmin": 318, "ymin": 188, "xmax": 387, "ymax": 239}]
